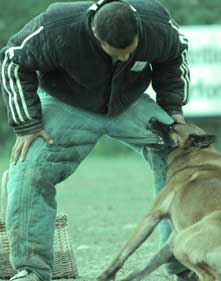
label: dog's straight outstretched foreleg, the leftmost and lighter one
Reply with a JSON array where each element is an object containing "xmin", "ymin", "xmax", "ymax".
[{"xmin": 97, "ymin": 210, "xmax": 162, "ymax": 281}]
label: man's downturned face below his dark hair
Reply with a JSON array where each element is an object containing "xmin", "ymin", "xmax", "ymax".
[{"xmin": 93, "ymin": 29, "xmax": 139, "ymax": 62}]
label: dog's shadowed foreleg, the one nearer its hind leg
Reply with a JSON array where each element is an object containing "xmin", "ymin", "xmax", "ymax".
[{"xmin": 121, "ymin": 232, "xmax": 175, "ymax": 281}]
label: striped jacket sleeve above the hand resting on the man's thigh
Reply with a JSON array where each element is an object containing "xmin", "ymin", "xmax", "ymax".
[{"xmin": 0, "ymin": 15, "xmax": 54, "ymax": 134}]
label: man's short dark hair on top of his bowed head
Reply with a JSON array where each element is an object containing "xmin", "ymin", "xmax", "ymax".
[{"xmin": 93, "ymin": 1, "xmax": 139, "ymax": 49}]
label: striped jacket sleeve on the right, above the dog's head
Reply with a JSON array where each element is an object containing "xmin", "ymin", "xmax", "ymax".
[{"xmin": 152, "ymin": 20, "xmax": 190, "ymax": 115}]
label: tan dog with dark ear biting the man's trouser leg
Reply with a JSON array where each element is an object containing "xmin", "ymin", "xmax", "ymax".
[{"xmin": 97, "ymin": 125, "xmax": 221, "ymax": 281}]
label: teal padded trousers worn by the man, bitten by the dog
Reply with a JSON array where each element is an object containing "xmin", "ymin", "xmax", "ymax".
[{"xmin": 6, "ymin": 91, "xmax": 186, "ymax": 281}]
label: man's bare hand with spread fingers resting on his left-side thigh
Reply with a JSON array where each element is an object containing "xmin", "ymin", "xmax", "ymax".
[{"xmin": 10, "ymin": 130, "xmax": 53, "ymax": 165}]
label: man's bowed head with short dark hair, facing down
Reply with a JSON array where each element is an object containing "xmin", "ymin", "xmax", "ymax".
[{"xmin": 92, "ymin": 1, "xmax": 139, "ymax": 61}]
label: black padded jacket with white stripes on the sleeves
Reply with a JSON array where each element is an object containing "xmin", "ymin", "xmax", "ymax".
[{"xmin": 1, "ymin": 0, "xmax": 189, "ymax": 134}]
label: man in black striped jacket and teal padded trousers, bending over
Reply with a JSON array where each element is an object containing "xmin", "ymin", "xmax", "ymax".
[{"xmin": 1, "ymin": 0, "xmax": 194, "ymax": 281}]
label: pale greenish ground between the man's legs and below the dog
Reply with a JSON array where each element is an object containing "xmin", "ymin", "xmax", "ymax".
[{"xmin": 54, "ymin": 155, "xmax": 173, "ymax": 281}]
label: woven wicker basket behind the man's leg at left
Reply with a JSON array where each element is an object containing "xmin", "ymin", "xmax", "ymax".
[{"xmin": 0, "ymin": 173, "xmax": 78, "ymax": 279}]
